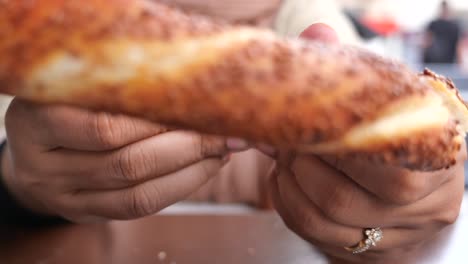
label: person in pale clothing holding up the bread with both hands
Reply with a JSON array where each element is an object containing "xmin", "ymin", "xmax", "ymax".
[{"xmin": 0, "ymin": 0, "xmax": 466, "ymax": 263}]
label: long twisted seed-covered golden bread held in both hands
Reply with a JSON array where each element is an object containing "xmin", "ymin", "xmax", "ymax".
[{"xmin": 0, "ymin": 0, "xmax": 468, "ymax": 170}]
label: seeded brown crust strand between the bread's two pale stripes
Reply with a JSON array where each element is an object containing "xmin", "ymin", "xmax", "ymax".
[{"xmin": 54, "ymin": 40, "xmax": 427, "ymax": 146}]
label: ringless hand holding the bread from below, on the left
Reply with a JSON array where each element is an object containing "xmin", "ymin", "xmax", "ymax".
[{"xmin": 2, "ymin": 100, "xmax": 244, "ymax": 222}]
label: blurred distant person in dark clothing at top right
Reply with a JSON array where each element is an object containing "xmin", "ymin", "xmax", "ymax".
[{"xmin": 424, "ymin": 1, "xmax": 461, "ymax": 64}]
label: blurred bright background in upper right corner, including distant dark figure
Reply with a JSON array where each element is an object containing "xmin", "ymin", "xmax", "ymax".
[{"xmin": 338, "ymin": 0, "xmax": 468, "ymax": 89}]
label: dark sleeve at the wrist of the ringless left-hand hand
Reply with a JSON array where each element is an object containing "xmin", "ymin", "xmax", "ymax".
[{"xmin": 0, "ymin": 141, "xmax": 67, "ymax": 227}]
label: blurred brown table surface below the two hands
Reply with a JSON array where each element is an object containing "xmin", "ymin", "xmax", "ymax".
[{"xmin": 0, "ymin": 194, "xmax": 468, "ymax": 264}]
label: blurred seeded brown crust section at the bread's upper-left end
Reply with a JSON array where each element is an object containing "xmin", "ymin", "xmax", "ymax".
[{"xmin": 0, "ymin": 0, "xmax": 227, "ymax": 92}]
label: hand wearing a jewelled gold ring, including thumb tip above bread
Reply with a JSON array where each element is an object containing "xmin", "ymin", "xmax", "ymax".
[{"xmin": 270, "ymin": 25, "xmax": 466, "ymax": 263}]
